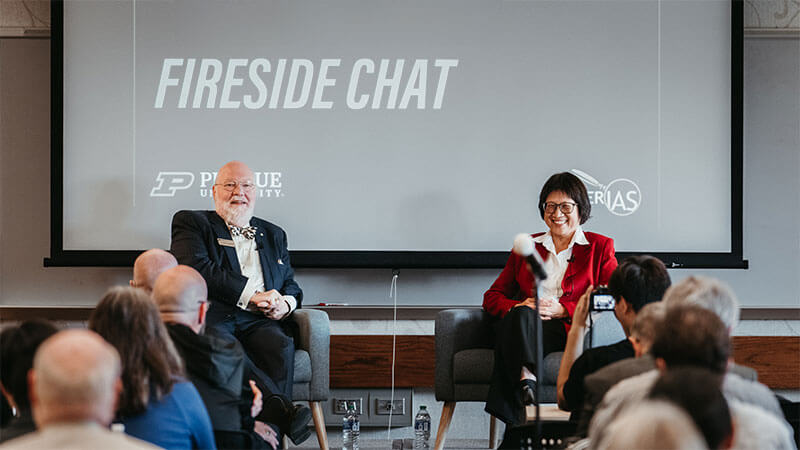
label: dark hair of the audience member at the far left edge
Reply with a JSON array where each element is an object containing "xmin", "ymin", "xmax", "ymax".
[{"xmin": 0, "ymin": 319, "xmax": 58, "ymax": 411}]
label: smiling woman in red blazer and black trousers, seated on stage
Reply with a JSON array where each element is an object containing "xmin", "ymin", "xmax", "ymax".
[{"xmin": 483, "ymin": 172, "xmax": 617, "ymax": 425}]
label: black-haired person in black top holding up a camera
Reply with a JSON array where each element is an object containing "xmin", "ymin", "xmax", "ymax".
[{"xmin": 556, "ymin": 255, "xmax": 670, "ymax": 419}]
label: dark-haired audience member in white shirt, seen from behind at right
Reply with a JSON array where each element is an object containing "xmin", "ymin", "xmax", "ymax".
[{"xmin": 589, "ymin": 304, "xmax": 793, "ymax": 448}]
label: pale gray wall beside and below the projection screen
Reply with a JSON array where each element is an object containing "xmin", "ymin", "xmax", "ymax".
[{"xmin": 0, "ymin": 38, "xmax": 800, "ymax": 314}]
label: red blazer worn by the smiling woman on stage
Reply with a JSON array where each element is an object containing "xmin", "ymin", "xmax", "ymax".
[{"xmin": 483, "ymin": 232, "xmax": 617, "ymax": 331}]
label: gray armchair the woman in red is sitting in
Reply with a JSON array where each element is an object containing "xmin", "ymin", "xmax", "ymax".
[{"xmin": 434, "ymin": 308, "xmax": 625, "ymax": 450}]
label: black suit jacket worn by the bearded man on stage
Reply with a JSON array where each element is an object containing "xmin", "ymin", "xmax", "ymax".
[{"xmin": 170, "ymin": 211, "xmax": 303, "ymax": 309}]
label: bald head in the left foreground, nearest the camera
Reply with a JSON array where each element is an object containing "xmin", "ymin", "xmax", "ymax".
[{"xmin": 30, "ymin": 330, "xmax": 120, "ymax": 427}]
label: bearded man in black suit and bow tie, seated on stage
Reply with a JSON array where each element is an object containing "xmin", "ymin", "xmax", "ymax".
[{"xmin": 170, "ymin": 161, "xmax": 311, "ymax": 443}]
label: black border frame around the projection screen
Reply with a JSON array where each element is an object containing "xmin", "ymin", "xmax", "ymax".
[{"xmin": 44, "ymin": 0, "xmax": 748, "ymax": 269}]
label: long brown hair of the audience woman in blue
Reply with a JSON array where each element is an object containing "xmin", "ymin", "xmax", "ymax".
[{"xmin": 89, "ymin": 287, "xmax": 183, "ymax": 417}]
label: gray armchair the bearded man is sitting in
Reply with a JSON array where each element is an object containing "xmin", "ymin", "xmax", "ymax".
[{"xmin": 284, "ymin": 309, "xmax": 331, "ymax": 450}]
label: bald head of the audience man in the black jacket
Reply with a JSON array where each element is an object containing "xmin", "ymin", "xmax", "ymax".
[{"xmin": 153, "ymin": 265, "xmax": 208, "ymax": 331}]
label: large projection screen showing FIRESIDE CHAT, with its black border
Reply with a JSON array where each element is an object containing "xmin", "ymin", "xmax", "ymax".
[{"xmin": 45, "ymin": 0, "xmax": 746, "ymax": 267}]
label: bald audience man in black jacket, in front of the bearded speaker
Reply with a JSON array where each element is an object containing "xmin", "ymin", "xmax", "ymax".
[{"xmin": 153, "ymin": 265, "xmax": 278, "ymax": 449}]
